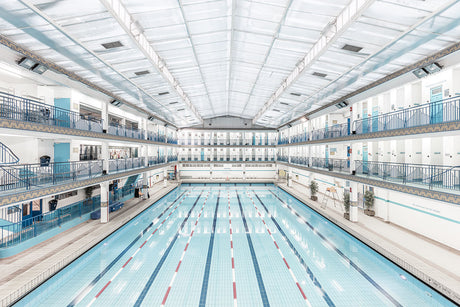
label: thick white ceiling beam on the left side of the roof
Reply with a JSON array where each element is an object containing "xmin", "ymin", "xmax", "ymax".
[{"xmin": 100, "ymin": 0, "xmax": 203, "ymax": 123}]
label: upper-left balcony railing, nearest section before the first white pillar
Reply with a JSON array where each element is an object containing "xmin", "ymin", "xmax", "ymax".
[{"xmin": 0, "ymin": 92, "xmax": 102, "ymax": 132}]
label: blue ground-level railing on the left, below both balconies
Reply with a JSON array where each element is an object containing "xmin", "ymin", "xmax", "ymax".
[{"xmin": 0, "ymin": 196, "xmax": 101, "ymax": 248}]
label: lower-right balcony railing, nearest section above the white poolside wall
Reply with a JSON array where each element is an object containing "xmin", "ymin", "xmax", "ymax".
[{"xmin": 355, "ymin": 160, "xmax": 460, "ymax": 190}]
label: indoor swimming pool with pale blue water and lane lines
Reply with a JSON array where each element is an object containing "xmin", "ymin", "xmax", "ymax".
[{"xmin": 16, "ymin": 184, "xmax": 454, "ymax": 307}]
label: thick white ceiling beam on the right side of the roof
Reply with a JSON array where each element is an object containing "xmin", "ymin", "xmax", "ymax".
[{"xmin": 253, "ymin": 0, "xmax": 375, "ymax": 124}]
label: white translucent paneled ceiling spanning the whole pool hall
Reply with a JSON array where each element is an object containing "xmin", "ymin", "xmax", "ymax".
[{"xmin": 0, "ymin": 0, "xmax": 460, "ymax": 127}]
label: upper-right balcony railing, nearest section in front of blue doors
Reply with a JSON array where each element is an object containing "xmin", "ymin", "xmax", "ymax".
[{"xmin": 353, "ymin": 97, "xmax": 460, "ymax": 134}]
